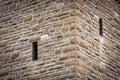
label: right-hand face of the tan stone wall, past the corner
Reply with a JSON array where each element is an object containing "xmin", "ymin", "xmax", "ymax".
[{"xmin": 74, "ymin": 0, "xmax": 120, "ymax": 80}]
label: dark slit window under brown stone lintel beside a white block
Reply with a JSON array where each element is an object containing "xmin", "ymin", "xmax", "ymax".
[{"xmin": 32, "ymin": 41, "xmax": 38, "ymax": 61}]
